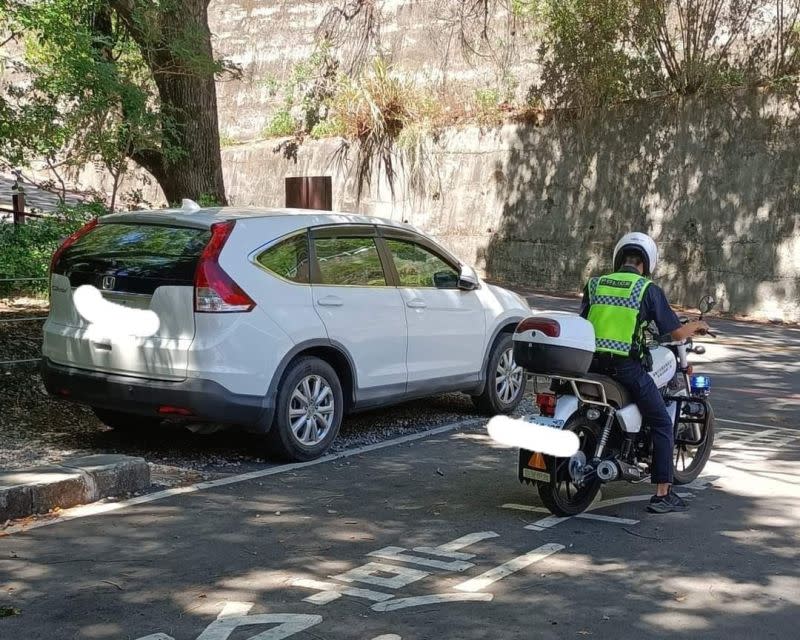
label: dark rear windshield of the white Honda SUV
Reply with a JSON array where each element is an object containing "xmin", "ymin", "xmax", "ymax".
[{"xmin": 54, "ymin": 224, "xmax": 211, "ymax": 295}]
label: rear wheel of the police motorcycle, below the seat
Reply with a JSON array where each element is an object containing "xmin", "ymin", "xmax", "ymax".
[{"xmin": 536, "ymin": 415, "xmax": 601, "ymax": 516}]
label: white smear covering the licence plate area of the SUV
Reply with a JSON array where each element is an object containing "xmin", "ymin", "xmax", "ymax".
[{"xmin": 72, "ymin": 284, "xmax": 161, "ymax": 338}]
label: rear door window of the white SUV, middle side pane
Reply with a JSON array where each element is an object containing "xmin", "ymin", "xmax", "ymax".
[{"xmin": 313, "ymin": 236, "xmax": 386, "ymax": 287}]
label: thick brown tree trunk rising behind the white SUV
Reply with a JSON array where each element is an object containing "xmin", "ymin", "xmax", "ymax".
[{"xmin": 112, "ymin": 0, "xmax": 227, "ymax": 204}]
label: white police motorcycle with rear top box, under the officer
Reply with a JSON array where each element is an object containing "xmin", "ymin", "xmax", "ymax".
[{"xmin": 514, "ymin": 296, "xmax": 715, "ymax": 516}]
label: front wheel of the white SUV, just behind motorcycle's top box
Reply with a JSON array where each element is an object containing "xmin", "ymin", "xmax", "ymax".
[{"xmin": 472, "ymin": 333, "xmax": 528, "ymax": 416}]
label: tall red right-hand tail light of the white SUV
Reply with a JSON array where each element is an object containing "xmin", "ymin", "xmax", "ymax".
[{"xmin": 194, "ymin": 220, "xmax": 256, "ymax": 313}]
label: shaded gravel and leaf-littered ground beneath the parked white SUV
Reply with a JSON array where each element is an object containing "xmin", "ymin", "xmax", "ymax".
[{"xmin": 0, "ymin": 301, "xmax": 530, "ymax": 487}]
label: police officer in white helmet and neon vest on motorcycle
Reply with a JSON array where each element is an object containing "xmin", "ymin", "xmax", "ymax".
[{"xmin": 581, "ymin": 233, "xmax": 708, "ymax": 513}]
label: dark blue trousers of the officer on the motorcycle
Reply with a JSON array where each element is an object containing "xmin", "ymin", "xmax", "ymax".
[{"xmin": 599, "ymin": 358, "xmax": 675, "ymax": 484}]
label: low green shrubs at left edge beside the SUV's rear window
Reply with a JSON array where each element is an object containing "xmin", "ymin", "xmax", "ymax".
[{"xmin": 0, "ymin": 203, "xmax": 108, "ymax": 295}]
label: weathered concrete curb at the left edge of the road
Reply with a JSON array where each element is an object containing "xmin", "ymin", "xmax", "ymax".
[{"xmin": 0, "ymin": 454, "xmax": 150, "ymax": 522}]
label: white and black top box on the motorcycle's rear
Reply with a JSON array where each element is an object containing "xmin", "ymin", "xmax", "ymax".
[{"xmin": 514, "ymin": 311, "xmax": 594, "ymax": 377}]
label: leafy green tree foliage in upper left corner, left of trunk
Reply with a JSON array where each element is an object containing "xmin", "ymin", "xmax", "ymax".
[{"xmin": 0, "ymin": 0, "xmax": 161, "ymax": 178}]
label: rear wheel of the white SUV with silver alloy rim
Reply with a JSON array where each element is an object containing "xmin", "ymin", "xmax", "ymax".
[{"xmin": 267, "ymin": 356, "xmax": 344, "ymax": 462}]
